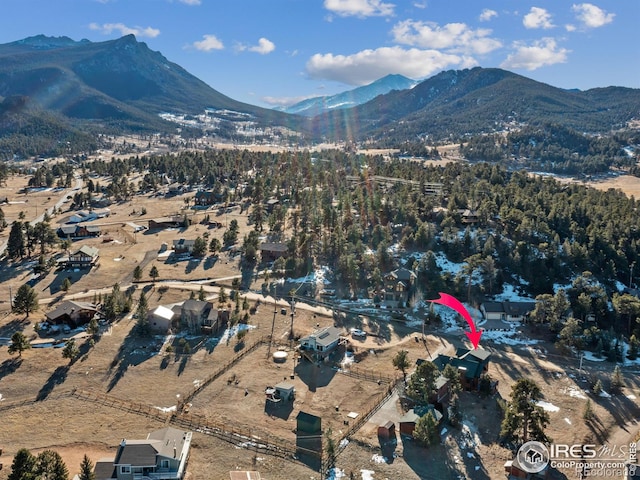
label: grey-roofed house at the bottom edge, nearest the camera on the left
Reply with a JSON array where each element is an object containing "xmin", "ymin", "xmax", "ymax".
[{"xmin": 94, "ymin": 427, "xmax": 192, "ymax": 480}]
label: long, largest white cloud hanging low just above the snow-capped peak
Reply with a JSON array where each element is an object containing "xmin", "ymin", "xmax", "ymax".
[{"xmin": 306, "ymin": 46, "xmax": 464, "ymax": 85}]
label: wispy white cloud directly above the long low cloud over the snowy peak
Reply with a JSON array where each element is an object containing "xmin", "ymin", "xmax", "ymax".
[{"xmin": 391, "ymin": 20, "xmax": 502, "ymax": 55}]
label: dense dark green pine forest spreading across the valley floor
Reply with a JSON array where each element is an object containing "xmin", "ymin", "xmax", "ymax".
[{"xmin": 31, "ymin": 151, "xmax": 640, "ymax": 334}]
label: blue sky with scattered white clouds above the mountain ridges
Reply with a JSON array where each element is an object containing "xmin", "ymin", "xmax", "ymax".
[{"xmin": 0, "ymin": 0, "xmax": 640, "ymax": 106}]
